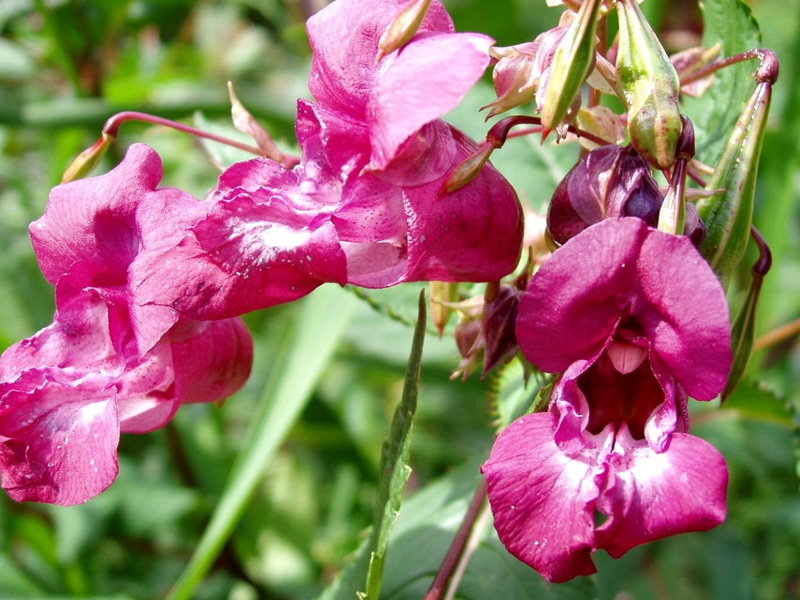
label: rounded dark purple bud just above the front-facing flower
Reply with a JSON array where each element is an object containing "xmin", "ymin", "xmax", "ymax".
[{"xmin": 547, "ymin": 144, "xmax": 663, "ymax": 244}]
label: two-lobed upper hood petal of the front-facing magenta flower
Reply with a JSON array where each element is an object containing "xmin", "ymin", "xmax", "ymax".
[{"xmin": 517, "ymin": 217, "xmax": 732, "ymax": 400}]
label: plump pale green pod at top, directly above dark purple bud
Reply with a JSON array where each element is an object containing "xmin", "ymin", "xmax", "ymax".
[{"xmin": 616, "ymin": 0, "xmax": 681, "ymax": 170}]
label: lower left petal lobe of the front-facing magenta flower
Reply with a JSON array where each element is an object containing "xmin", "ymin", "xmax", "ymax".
[{"xmin": 481, "ymin": 413, "xmax": 602, "ymax": 582}]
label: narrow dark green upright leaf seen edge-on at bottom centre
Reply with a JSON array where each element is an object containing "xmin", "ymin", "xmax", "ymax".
[{"xmin": 359, "ymin": 292, "xmax": 428, "ymax": 600}]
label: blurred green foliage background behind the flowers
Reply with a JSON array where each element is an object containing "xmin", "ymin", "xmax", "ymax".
[{"xmin": 0, "ymin": 0, "xmax": 800, "ymax": 600}]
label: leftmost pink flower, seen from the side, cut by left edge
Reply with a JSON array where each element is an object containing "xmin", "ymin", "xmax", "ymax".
[{"xmin": 0, "ymin": 145, "xmax": 253, "ymax": 505}]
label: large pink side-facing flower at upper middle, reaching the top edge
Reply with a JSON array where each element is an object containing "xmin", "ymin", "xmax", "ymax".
[{"xmin": 138, "ymin": 0, "xmax": 522, "ymax": 319}]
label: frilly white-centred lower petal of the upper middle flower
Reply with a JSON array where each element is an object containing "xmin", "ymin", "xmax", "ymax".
[{"xmin": 135, "ymin": 169, "xmax": 346, "ymax": 319}]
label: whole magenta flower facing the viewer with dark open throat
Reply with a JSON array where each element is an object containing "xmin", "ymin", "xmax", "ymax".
[{"xmin": 482, "ymin": 217, "xmax": 732, "ymax": 582}]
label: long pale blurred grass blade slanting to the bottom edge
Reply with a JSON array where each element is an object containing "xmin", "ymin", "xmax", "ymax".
[{"xmin": 167, "ymin": 285, "xmax": 356, "ymax": 600}]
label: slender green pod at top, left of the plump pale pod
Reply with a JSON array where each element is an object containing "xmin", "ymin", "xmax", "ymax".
[{"xmin": 541, "ymin": 0, "xmax": 602, "ymax": 136}]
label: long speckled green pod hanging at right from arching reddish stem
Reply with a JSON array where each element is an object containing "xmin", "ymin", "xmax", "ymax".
[{"xmin": 697, "ymin": 81, "xmax": 772, "ymax": 287}]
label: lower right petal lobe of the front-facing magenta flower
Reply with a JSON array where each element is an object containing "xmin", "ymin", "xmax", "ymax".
[{"xmin": 596, "ymin": 432, "xmax": 728, "ymax": 558}]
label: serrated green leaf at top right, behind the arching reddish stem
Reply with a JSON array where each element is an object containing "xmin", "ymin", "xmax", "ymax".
[{"xmin": 683, "ymin": 0, "xmax": 761, "ymax": 165}]
